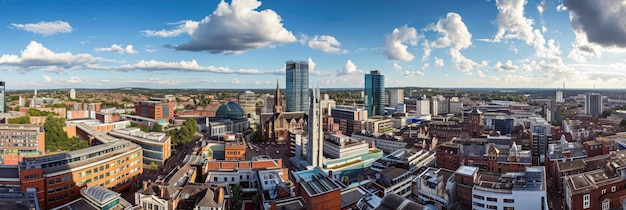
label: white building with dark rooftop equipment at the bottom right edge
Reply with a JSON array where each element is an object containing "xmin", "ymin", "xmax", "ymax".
[{"xmin": 472, "ymin": 166, "xmax": 548, "ymax": 210}]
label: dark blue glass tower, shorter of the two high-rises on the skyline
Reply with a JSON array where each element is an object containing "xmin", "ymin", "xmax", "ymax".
[{"xmin": 365, "ymin": 70, "xmax": 385, "ymax": 116}]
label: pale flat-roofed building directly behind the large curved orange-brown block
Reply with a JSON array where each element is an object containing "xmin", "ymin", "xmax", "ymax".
[{"xmin": 109, "ymin": 128, "xmax": 172, "ymax": 165}]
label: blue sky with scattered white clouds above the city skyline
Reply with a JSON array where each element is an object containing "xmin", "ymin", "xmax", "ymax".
[{"xmin": 0, "ymin": 0, "xmax": 626, "ymax": 89}]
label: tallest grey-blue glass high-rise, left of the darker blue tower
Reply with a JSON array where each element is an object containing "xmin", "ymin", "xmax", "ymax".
[{"xmin": 285, "ymin": 61, "xmax": 309, "ymax": 112}]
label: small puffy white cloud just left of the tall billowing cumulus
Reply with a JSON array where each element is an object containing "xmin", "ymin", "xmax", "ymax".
[{"xmin": 384, "ymin": 25, "xmax": 419, "ymax": 61}]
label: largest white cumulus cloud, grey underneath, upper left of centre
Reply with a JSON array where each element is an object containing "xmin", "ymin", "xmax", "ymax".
[{"xmin": 153, "ymin": 0, "xmax": 296, "ymax": 54}]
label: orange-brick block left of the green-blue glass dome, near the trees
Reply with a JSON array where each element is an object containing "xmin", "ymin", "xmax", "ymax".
[{"xmin": 133, "ymin": 95, "xmax": 175, "ymax": 121}]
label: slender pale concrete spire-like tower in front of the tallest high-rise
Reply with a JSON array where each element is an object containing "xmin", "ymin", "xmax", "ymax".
[{"xmin": 306, "ymin": 88, "xmax": 324, "ymax": 167}]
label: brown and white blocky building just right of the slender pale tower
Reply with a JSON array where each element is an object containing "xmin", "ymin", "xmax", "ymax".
[{"xmin": 330, "ymin": 106, "xmax": 367, "ymax": 135}]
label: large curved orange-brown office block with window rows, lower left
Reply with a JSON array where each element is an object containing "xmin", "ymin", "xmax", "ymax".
[{"xmin": 17, "ymin": 137, "xmax": 143, "ymax": 209}]
